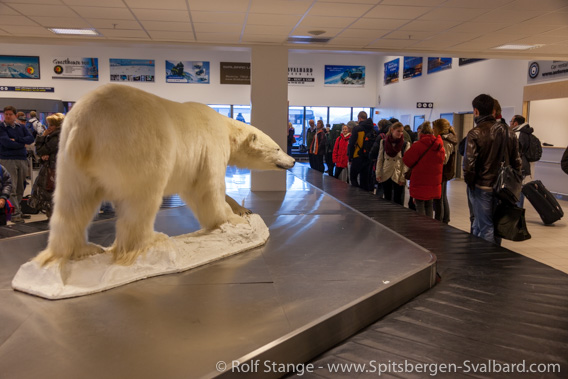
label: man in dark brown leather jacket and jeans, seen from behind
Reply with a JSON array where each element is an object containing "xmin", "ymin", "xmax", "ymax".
[{"xmin": 464, "ymin": 94, "xmax": 522, "ymax": 244}]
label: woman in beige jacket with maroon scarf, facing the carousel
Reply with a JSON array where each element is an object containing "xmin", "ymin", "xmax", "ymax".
[{"xmin": 375, "ymin": 122, "xmax": 410, "ymax": 205}]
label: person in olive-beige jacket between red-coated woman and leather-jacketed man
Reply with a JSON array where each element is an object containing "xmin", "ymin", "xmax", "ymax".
[{"xmin": 432, "ymin": 118, "xmax": 458, "ymax": 224}]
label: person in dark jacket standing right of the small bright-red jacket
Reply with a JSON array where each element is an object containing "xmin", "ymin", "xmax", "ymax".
[{"xmin": 347, "ymin": 111, "xmax": 373, "ymax": 191}]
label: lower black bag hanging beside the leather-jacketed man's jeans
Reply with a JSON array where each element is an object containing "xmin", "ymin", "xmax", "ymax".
[{"xmin": 493, "ymin": 202, "xmax": 531, "ymax": 241}]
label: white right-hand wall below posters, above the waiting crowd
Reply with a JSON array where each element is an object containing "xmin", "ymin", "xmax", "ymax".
[{"xmin": 378, "ymin": 56, "xmax": 528, "ymax": 126}]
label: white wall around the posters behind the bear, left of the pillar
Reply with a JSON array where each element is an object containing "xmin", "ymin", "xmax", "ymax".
[{"xmin": 0, "ymin": 44, "xmax": 250, "ymax": 105}]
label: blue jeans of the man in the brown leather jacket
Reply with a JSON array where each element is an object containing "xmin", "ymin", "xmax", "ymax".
[{"xmin": 467, "ymin": 187, "xmax": 501, "ymax": 245}]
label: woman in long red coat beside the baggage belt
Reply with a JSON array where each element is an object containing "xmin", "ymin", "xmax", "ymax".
[{"xmin": 402, "ymin": 122, "xmax": 445, "ymax": 217}]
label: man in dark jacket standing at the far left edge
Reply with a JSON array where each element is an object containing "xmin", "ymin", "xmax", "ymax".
[{"xmin": 0, "ymin": 106, "xmax": 34, "ymax": 223}]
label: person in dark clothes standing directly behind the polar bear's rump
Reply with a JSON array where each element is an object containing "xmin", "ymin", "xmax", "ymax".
[{"xmin": 30, "ymin": 113, "xmax": 65, "ymax": 218}]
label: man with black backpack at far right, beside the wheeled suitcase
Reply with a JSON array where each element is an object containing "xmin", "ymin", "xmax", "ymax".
[{"xmin": 511, "ymin": 115, "xmax": 542, "ymax": 208}]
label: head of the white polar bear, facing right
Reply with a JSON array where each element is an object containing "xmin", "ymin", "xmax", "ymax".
[{"xmin": 229, "ymin": 125, "xmax": 296, "ymax": 170}]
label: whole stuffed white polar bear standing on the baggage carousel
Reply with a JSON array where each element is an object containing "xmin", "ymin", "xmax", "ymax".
[{"xmin": 35, "ymin": 84, "xmax": 294, "ymax": 265}]
